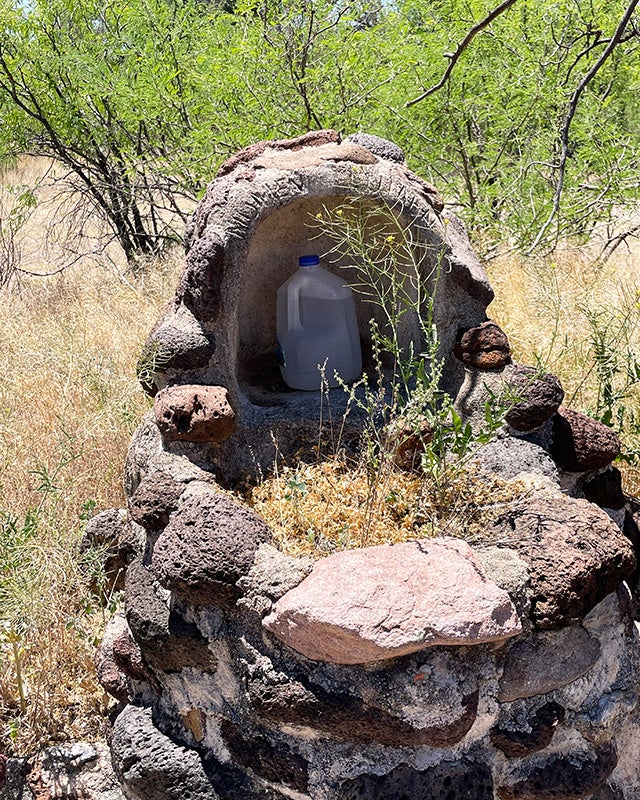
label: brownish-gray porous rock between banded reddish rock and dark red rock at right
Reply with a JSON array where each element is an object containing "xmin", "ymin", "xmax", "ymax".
[{"xmin": 505, "ymin": 364, "xmax": 564, "ymax": 431}]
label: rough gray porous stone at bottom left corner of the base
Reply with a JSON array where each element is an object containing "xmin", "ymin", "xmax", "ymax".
[{"xmin": 111, "ymin": 706, "xmax": 218, "ymax": 800}]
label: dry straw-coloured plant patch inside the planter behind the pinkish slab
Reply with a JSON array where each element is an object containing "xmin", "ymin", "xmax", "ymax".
[{"xmin": 245, "ymin": 456, "xmax": 528, "ymax": 557}]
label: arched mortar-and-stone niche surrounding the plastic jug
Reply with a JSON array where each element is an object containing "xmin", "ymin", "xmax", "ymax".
[{"xmin": 140, "ymin": 131, "xmax": 493, "ymax": 475}]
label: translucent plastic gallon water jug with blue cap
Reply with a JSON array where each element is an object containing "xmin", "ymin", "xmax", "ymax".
[{"xmin": 276, "ymin": 256, "xmax": 362, "ymax": 391}]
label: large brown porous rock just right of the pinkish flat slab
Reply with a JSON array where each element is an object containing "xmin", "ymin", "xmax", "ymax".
[{"xmin": 492, "ymin": 496, "xmax": 635, "ymax": 628}]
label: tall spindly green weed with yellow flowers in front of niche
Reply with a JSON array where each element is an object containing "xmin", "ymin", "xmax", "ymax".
[{"xmin": 316, "ymin": 201, "xmax": 513, "ymax": 513}]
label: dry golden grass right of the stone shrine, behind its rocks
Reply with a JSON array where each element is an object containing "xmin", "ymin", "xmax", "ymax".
[{"xmin": 487, "ymin": 233, "xmax": 640, "ymax": 495}]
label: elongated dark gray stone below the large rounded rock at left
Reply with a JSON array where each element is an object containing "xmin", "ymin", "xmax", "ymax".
[{"xmin": 125, "ymin": 560, "xmax": 216, "ymax": 672}]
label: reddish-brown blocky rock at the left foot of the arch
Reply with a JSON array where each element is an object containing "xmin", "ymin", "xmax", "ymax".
[{"xmin": 154, "ymin": 385, "xmax": 236, "ymax": 442}]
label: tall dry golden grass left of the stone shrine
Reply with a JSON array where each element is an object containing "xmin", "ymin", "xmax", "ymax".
[{"xmin": 0, "ymin": 255, "xmax": 176, "ymax": 752}]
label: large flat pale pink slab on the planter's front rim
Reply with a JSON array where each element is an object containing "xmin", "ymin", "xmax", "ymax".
[{"xmin": 263, "ymin": 538, "xmax": 521, "ymax": 664}]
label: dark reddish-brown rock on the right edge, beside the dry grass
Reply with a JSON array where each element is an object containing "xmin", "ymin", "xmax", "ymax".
[{"xmin": 550, "ymin": 408, "xmax": 620, "ymax": 472}]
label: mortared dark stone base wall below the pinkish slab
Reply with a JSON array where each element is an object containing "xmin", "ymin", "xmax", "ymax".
[{"xmin": 104, "ymin": 584, "xmax": 640, "ymax": 800}]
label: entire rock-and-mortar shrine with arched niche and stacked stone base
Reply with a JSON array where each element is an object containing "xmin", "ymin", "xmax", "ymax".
[{"xmin": 87, "ymin": 131, "xmax": 640, "ymax": 800}]
